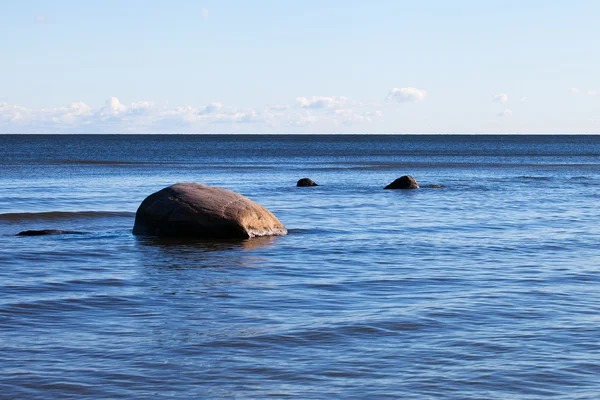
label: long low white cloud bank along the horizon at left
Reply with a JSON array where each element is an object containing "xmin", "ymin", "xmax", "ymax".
[{"xmin": 0, "ymin": 96, "xmax": 383, "ymax": 133}]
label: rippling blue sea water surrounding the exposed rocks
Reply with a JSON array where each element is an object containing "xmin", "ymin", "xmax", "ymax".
[{"xmin": 0, "ymin": 135, "xmax": 600, "ymax": 399}]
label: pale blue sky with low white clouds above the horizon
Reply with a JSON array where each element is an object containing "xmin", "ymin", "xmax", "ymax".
[{"xmin": 0, "ymin": 0, "xmax": 600, "ymax": 133}]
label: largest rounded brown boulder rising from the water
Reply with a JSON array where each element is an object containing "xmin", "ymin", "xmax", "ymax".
[{"xmin": 133, "ymin": 183, "xmax": 287, "ymax": 239}]
